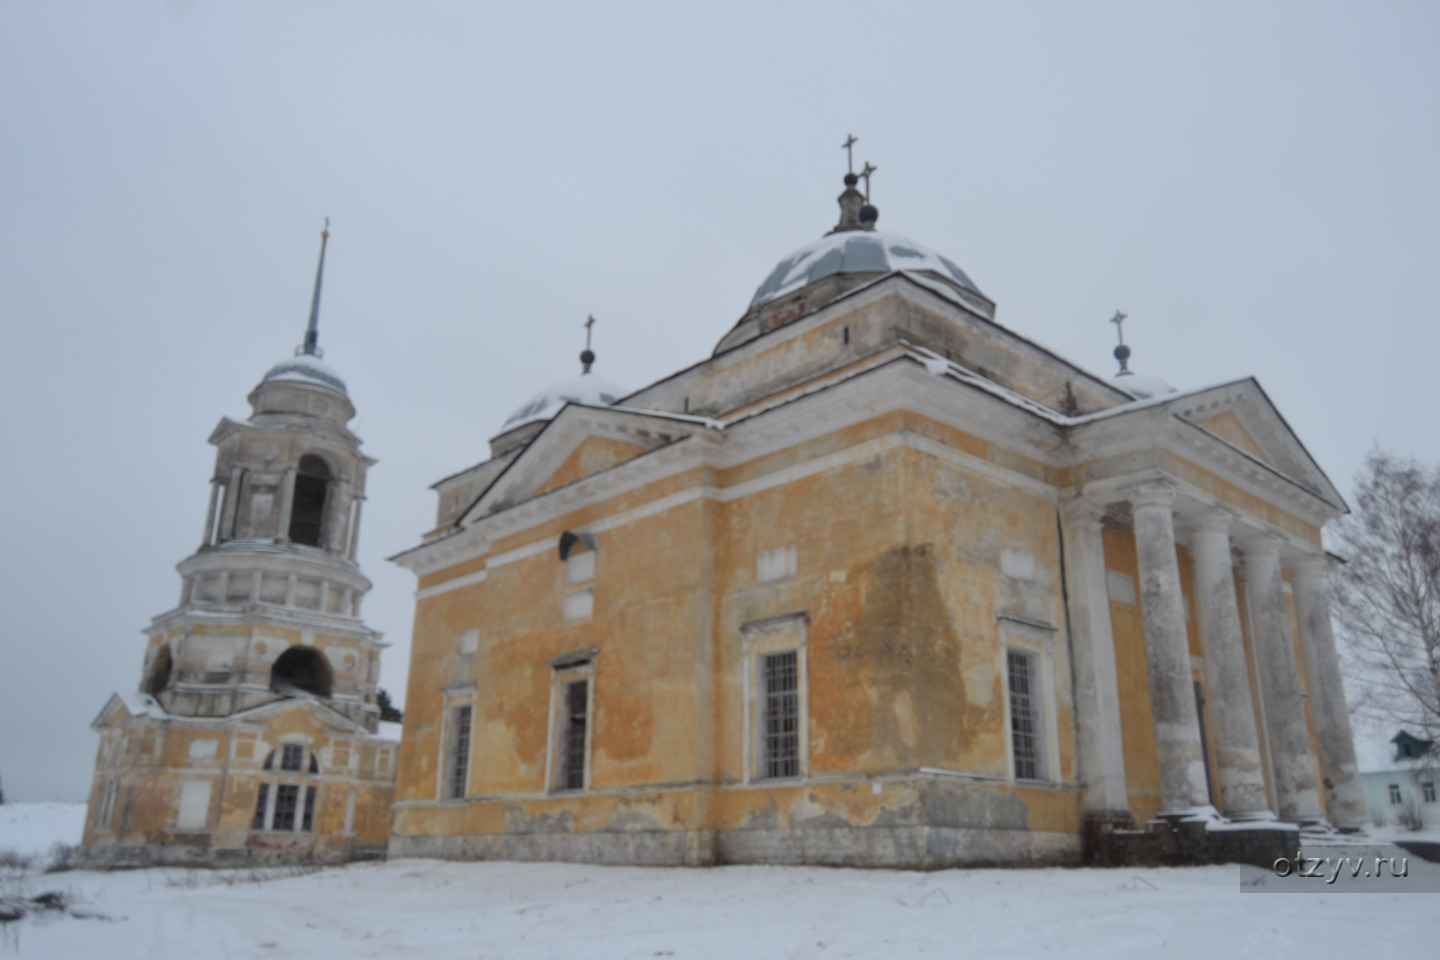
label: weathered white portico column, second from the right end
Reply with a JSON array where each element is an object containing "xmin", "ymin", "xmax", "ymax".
[{"xmin": 1244, "ymin": 535, "xmax": 1323, "ymax": 823}]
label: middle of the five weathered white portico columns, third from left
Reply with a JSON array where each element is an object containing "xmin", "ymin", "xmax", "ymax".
[{"xmin": 1189, "ymin": 510, "xmax": 1274, "ymax": 820}]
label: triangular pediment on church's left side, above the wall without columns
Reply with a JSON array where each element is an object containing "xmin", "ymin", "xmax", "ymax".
[{"xmin": 461, "ymin": 403, "xmax": 707, "ymax": 524}]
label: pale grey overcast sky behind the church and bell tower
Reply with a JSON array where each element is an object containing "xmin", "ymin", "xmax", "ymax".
[{"xmin": 0, "ymin": 0, "xmax": 1440, "ymax": 800}]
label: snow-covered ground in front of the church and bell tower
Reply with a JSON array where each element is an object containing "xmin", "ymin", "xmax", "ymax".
[{"xmin": 0, "ymin": 805, "xmax": 1440, "ymax": 960}]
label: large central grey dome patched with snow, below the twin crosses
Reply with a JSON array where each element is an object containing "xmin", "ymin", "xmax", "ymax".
[{"xmin": 750, "ymin": 230, "xmax": 981, "ymax": 309}]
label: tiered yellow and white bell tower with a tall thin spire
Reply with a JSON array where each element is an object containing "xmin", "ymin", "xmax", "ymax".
[{"xmin": 81, "ymin": 230, "xmax": 397, "ymax": 866}]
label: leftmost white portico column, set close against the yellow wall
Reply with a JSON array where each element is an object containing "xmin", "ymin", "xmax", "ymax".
[{"xmin": 1061, "ymin": 501, "xmax": 1130, "ymax": 820}]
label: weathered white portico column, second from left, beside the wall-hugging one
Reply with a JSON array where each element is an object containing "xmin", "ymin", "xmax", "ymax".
[{"xmin": 1130, "ymin": 481, "xmax": 1212, "ymax": 816}]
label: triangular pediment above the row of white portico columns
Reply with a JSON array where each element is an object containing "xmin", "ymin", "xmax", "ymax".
[{"xmin": 1171, "ymin": 377, "xmax": 1348, "ymax": 510}]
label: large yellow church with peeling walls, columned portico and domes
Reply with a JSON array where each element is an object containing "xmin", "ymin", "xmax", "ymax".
[{"xmin": 389, "ymin": 168, "xmax": 1365, "ymax": 866}]
